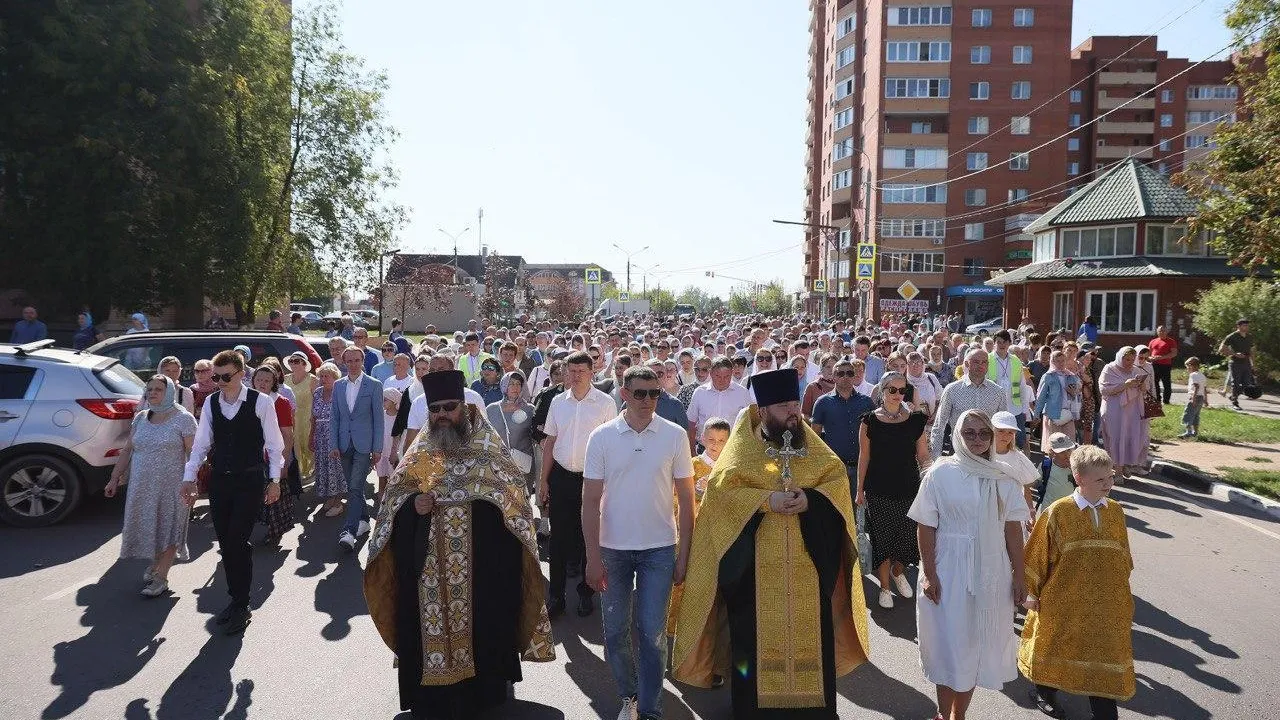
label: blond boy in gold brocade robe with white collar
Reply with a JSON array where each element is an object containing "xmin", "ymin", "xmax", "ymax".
[{"xmin": 1018, "ymin": 445, "xmax": 1134, "ymax": 720}]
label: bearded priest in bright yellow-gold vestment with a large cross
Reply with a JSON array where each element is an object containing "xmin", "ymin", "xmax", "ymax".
[{"xmin": 672, "ymin": 368, "xmax": 869, "ymax": 719}]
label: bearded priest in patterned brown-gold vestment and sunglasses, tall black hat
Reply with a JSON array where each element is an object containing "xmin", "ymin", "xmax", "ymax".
[{"xmin": 365, "ymin": 370, "xmax": 556, "ymax": 720}]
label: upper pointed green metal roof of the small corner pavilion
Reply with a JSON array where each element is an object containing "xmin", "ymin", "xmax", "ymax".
[{"xmin": 1023, "ymin": 158, "xmax": 1198, "ymax": 234}]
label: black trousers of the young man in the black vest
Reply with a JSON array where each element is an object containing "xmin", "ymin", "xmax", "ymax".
[{"xmin": 209, "ymin": 468, "xmax": 266, "ymax": 607}]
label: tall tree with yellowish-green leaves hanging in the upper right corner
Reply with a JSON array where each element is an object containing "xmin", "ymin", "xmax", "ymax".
[{"xmin": 1179, "ymin": 0, "xmax": 1280, "ymax": 268}]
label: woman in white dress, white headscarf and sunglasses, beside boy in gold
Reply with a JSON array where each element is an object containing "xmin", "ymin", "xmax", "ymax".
[{"xmin": 908, "ymin": 410, "xmax": 1030, "ymax": 720}]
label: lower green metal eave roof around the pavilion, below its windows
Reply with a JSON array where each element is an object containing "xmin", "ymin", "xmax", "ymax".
[{"xmin": 986, "ymin": 255, "xmax": 1272, "ymax": 287}]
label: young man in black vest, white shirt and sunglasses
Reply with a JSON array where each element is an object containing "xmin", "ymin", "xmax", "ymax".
[{"xmin": 182, "ymin": 350, "xmax": 284, "ymax": 635}]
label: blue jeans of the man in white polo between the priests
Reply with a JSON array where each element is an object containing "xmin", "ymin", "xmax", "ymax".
[{"xmin": 601, "ymin": 540, "xmax": 676, "ymax": 717}]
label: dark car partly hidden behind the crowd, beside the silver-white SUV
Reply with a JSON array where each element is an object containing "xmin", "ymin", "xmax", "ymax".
[{"xmin": 88, "ymin": 331, "xmax": 320, "ymax": 384}]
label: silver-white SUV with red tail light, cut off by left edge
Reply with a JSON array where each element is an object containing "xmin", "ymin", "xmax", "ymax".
[{"xmin": 0, "ymin": 340, "xmax": 146, "ymax": 528}]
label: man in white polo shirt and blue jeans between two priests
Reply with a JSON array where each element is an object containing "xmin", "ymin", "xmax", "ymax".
[{"xmin": 586, "ymin": 368, "xmax": 694, "ymax": 720}]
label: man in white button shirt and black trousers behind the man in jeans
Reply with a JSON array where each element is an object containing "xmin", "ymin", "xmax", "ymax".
[{"xmin": 538, "ymin": 350, "xmax": 618, "ymax": 618}]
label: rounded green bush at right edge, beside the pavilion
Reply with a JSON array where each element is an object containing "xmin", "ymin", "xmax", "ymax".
[{"xmin": 1187, "ymin": 278, "xmax": 1280, "ymax": 375}]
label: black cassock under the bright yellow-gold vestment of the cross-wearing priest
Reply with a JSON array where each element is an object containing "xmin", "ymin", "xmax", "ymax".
[{"xmin": 718, "ymin": 489, "xmax": 845, "ymax": 720}]
